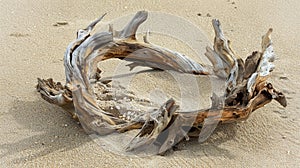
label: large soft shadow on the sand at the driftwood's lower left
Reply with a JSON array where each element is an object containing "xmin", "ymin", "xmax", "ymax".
[{"xmin": 0, "ymin": 100, "xmax": 91, "ymax": 163}]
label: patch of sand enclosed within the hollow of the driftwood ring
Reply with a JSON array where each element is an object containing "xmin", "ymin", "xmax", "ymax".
[{"xmin": 94, "ymin": 59, "xmax": 212, "ymax": 114}]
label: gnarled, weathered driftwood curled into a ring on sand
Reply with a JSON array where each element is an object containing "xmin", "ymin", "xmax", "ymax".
[{"xmin": 37, "ymin": 11, "xmax": 287, "ymax": 153}]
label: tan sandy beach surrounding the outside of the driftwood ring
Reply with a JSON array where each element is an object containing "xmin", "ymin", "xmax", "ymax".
[{"xmin": 0, "ymin": 0, "xmax": 300, "ymax": 168}]
